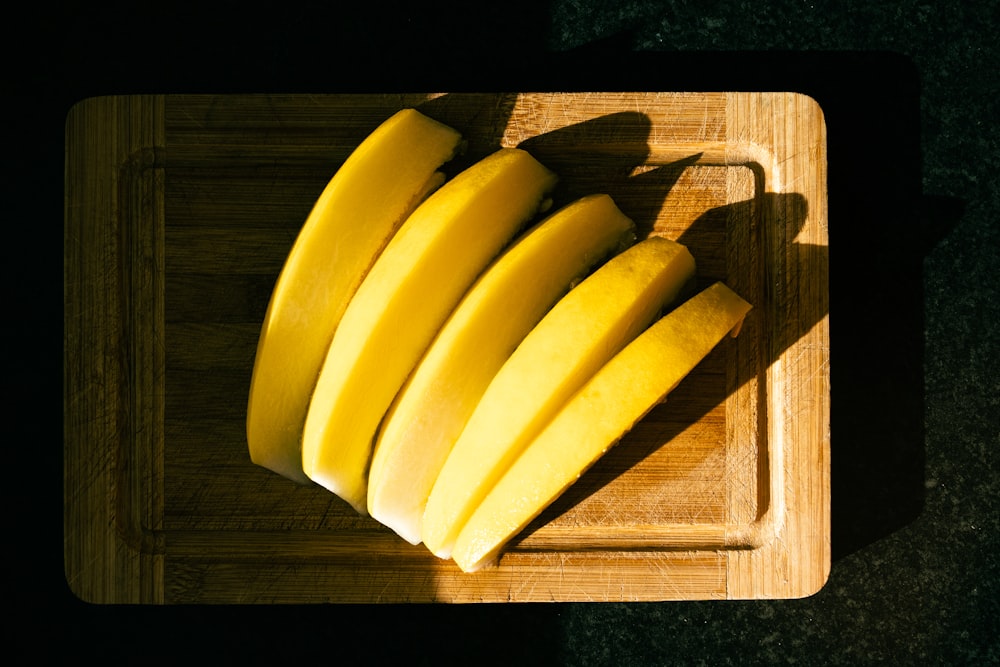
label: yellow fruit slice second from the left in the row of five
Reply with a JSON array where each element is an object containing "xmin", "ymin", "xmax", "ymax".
[{"xmin": 302, "ymin": 148, "xmax": 556, "ymax": 514}]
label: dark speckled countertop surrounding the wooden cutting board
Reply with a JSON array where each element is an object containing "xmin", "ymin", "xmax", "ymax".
[{"xmin": 11, "ymin": 0, "xmax": 1000, "ymax": 665}]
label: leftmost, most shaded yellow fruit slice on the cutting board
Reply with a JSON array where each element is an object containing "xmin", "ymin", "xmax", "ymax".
[{"xmin": 247, "ymin": 109, "xmax": 461, "ymax": 484}]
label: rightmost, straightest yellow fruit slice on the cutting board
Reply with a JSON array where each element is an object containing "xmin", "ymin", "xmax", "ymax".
[{"xmin": 452, "ymin": 283, "xmax": 750, "ymax": 572}]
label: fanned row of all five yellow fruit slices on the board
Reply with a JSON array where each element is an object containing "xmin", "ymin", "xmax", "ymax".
[{"xmin": 247, "ymin": 109, "xmax": 750, "ymax": 572}]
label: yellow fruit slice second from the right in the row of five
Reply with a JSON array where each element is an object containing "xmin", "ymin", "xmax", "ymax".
[{"xmin": 421, "ymin": 237, "xmax": 694, "ymax": 558}]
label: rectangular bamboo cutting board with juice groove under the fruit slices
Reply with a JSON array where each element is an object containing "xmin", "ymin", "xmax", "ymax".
[{"xmin": 64, "ymin": 93, "xmax": 830, "ymax": 604}]
